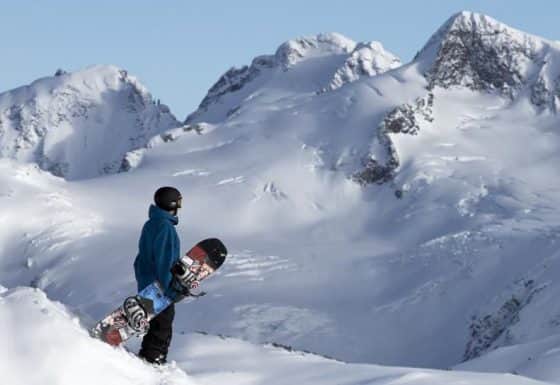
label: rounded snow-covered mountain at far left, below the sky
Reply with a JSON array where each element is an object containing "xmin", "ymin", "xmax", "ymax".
[{"xmin": 0, "ymin": 66, "xmax": 181, "ymax": 179}]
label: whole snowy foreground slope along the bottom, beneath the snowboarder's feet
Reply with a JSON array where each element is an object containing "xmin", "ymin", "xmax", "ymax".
[{"xmin": 0, "ymin": 288, "xmax": 544, "ymax": 385}]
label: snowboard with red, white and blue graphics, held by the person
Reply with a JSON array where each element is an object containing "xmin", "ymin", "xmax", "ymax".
[{"xmin": 90, "ymin": 238, "xmax": 227, "ymax": 346}]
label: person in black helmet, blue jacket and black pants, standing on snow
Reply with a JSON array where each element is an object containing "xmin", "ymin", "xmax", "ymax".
[{"xmin": 134, "ymin": 187, "xmax": 182, "ymax": 364}]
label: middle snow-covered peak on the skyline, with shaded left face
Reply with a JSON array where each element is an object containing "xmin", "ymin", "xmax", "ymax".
[{"xmin": 187, "ymin": 33, "xmax": 401, "ymax": 123}]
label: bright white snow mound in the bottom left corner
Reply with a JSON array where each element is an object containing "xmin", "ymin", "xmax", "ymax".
[{"xmin": 0, "ymin": 288, "xmax": 196, "ymax": 385}]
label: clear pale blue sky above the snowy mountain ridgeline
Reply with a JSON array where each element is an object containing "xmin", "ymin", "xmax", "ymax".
[{"xmin": 0, "ymin": 0, "xmax": 560, "ymax": 119}]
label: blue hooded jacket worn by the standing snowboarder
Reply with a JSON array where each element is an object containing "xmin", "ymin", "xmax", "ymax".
[{"xmin": 134, "ymin": 205, "xmax": 181, "ymax": 298}]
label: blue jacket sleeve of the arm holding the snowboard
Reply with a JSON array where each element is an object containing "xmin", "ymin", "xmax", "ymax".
[{"xmin": 154, "ymin": 226, "xmax": 180, "ymax": 298}]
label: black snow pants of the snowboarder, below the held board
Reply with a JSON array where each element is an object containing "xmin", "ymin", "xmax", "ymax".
[{"xmin": 138, "ymin": 304, "xmax": 175, "ymax": 363}]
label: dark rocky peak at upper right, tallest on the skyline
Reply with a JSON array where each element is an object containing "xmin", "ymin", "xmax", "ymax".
[{"xmin": 415, "ymin": 11, "xmax": 553, "ymax": 96}]
